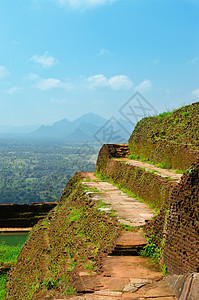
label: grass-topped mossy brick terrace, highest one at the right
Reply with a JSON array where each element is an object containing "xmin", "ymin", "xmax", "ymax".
[{"xmin": 129, "ymin": 102, "xmax": 199, "ymax": 171}]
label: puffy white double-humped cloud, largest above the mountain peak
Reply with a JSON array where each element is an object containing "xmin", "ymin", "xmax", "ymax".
[{"xmin": 88, "ymin": 74, "xmax": 133, "ymax": 90}]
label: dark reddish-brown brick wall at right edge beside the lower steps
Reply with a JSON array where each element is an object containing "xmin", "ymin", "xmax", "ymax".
[{"xmin": 145, "ymin": 160, "xmax": 199, "ymax": 274}]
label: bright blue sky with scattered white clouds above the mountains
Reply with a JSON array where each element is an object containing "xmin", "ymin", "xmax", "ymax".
[{"xmin": 0, "ymin": 0, "xmax": 199, "ymax": 126}]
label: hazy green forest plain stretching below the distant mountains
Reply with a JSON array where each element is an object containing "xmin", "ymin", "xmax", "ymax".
[{"xmin": 0, "ymin": 139, "xmax": 99, "ymax": 204}]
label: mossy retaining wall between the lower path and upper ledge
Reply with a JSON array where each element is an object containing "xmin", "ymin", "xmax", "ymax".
[{"xmin": 96, "ymin": 145, "xmax": 176, "ymax": 209}]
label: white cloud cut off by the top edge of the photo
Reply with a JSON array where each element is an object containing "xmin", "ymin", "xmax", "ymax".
[{"xmin": 54, "ymin": 0, "xmax": 117, "ymax": 9}]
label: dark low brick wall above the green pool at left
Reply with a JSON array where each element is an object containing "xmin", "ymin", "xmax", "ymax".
[{"xmin": 0, "ymin": 202, "xmax": 57, "ymax": 228}]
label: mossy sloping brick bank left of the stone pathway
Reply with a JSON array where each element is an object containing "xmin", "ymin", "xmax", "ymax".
[{"xmin": 6, "ymin": 174, "xmax": 119, "ymax": 300}]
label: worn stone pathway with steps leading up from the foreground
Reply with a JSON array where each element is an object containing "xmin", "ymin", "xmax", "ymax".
[{"xmin": 62, "ymin": 172, "xmax": 177, "ymax": 300}]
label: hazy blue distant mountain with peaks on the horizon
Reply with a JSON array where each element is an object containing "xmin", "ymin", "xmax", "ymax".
[{"xmin": 29, "ymin": 113, "xmax": 133, "ymax": 143}]
